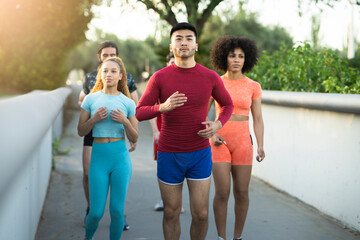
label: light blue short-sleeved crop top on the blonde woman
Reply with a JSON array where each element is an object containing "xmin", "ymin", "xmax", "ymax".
[{"xmin": 81, "ymin": 91, "xmax": 136, "ymax": 138}]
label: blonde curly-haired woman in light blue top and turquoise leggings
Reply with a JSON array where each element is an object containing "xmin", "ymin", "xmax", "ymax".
[{"xmin": 78, "ymin": 57, "xmax": 138, "ymax": 240}]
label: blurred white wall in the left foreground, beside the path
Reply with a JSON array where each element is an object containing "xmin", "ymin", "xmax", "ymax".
[{"xmin": 0, "ymin": 88, "xmax": 71, "ymax": 240}]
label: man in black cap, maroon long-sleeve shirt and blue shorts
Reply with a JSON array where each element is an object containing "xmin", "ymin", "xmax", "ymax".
[{"xmin": 136, "ymin": 23, "xmax": 233, "ymax": 240}]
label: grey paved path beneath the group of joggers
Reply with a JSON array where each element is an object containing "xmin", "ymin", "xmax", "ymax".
[{"xmin": 36, "ymin": 110, "xmax": 360, "ymax": 240}]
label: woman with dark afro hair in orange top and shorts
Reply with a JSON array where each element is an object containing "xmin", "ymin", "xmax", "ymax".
[{"xmin": 209, "ymin": 36, "xmax": 265, "ymax": 240}]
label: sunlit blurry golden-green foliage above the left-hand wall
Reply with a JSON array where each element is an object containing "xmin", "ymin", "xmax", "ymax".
[{"xmin": 0, "ymin": 0, "xmax": 97, "ymax": 92}]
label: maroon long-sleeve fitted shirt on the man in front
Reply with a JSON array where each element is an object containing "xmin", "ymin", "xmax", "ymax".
[{"xmin": 136, "ymin": 63, "xmax": 233, "ymax": 152}]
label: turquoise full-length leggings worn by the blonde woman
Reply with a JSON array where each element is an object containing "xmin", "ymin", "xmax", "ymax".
[{"xmin": 85, "ymin": 140, "xmax": 132, "ymax": 240}]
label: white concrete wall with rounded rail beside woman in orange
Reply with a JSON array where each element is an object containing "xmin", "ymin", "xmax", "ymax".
[{"xmin": 250, "ymin": 91, "xmax": 360, "ymax": 231}]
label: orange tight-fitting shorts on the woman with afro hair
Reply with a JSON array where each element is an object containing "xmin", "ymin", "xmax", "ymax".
[{"xmin": 210, "ymin": 121, "xmax": 253, "ymax": 165}]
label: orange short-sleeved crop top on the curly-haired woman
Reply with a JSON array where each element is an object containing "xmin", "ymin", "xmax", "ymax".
[{"xmin": 215, "ymin": 76, "xmax": 261, "ymax": 116}]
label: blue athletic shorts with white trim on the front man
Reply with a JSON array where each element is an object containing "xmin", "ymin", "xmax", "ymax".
[{"xmin": 157, "ymin": 147, "xmax": 212, "ymax": 185}]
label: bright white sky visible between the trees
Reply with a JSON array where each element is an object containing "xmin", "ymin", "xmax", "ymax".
[{"xmin": 87, "ymin": 0, "xmax": 360, "ymax": 49}]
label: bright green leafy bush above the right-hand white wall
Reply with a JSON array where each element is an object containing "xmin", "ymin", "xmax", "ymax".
[{"xmin": 248, "ymin": 42, "xmax": 360, "ymax": 94}]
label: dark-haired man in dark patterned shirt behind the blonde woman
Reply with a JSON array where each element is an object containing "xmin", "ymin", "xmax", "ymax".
[{"xmin": 78, "ymin": 41, "xmax": 139, "ymax": 230}]
